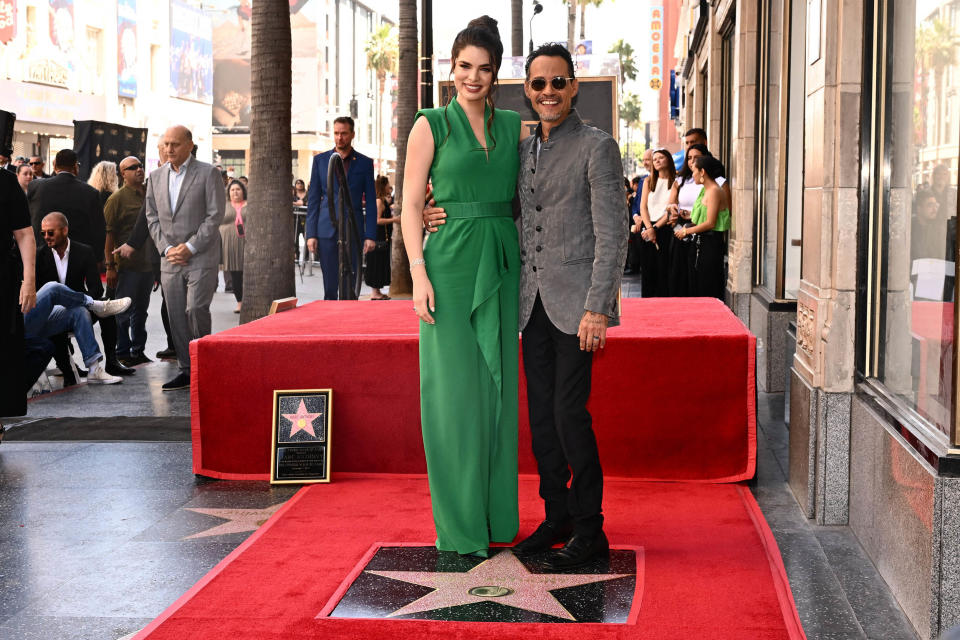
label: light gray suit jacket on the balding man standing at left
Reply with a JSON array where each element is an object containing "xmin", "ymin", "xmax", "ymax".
[{"xmin": 146, "ymin": 158, "xmax": 227, "ymax": 272}]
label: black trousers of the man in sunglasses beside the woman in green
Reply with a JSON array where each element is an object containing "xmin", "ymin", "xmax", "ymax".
[{"xmin": 523, "ymin": 295, "xmax": 603, "ymax": 535}]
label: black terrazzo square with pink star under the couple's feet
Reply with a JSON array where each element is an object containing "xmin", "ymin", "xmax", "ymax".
[{"xmin": 318, "ymin": 545, "xmax": 643, "ymax": 624}]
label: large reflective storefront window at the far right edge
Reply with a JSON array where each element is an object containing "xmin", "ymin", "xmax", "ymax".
[{"xmin": 867, "ymin": 0, "xmax": 960, "ymax": 435}]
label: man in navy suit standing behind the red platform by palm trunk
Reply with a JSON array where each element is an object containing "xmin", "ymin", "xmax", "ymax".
[{"xmin": 306, "ymin": 116, "xmax": 377, "ymax": 300}]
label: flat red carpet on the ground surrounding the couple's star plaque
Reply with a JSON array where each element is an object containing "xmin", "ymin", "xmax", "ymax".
[{"xmin": 136, "ymin": 474, "xmax": 804, "ymax": 640}]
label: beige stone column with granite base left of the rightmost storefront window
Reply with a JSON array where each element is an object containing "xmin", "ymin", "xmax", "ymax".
[{"xmin": 790, "ymin": 0, "xmax": 864, "ymax": 524}]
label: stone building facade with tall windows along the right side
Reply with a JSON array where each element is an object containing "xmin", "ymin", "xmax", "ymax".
[{"xmin": 676, "ymin": 0, "xmax": 960, "ymax": 638}]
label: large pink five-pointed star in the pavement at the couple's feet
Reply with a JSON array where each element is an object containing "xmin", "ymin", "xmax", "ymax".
[{"xmin": 366, "ymin": 551, "xmax": 633, "ymax": 622}]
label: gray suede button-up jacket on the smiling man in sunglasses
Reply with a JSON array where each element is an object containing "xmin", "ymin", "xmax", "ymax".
[{"xmin": 517, "ymin": 110, "xmax": 630, "ymax": 334}]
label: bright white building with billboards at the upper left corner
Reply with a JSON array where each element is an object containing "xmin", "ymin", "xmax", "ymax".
[{"xmin": 0, "ymin": 0, "xmax": 213, "ymax": 171}]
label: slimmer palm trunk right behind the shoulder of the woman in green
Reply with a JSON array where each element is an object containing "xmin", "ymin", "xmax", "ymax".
[{"xmin": 390, "ymin": 0, "xmax": 420, "ymax": 296}]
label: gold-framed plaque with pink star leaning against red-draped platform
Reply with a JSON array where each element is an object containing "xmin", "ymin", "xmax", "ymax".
[{"xmin": 270, "ymin": 389, "xmax": 333, "ymax": 484}]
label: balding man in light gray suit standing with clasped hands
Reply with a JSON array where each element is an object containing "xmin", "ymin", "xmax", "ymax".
[{"xmin": 146, "ymin": 126, "xmax": 226, "ymax": 391}]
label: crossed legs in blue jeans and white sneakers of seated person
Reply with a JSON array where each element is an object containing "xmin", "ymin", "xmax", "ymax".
[{"xmin": 23, "ymin": 282, "xmax": 130, "ymax": 384}]
